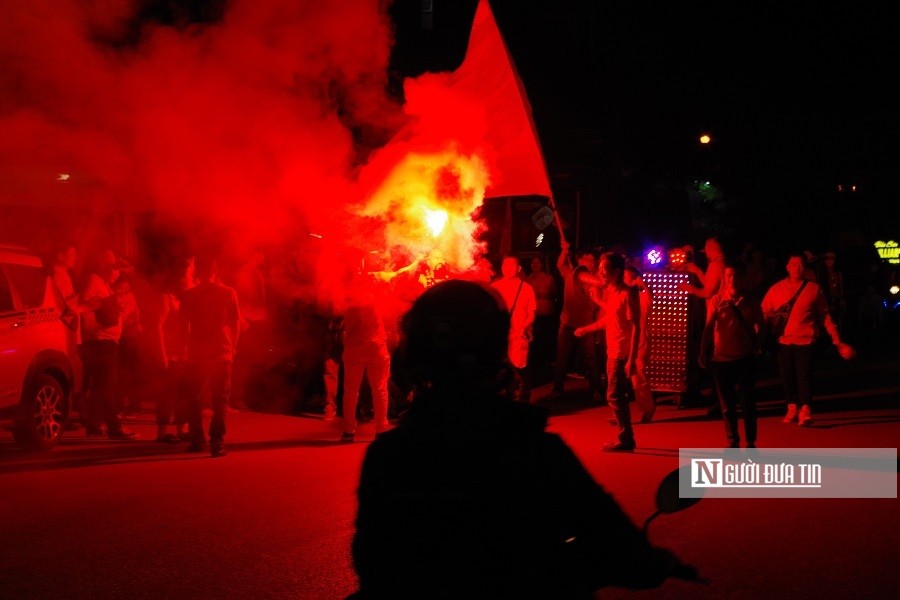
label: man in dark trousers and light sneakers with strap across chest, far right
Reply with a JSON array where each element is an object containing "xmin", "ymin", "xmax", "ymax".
[{"xmin": 762, "ymin": 253, "xmax": 856, "ymax": 427}]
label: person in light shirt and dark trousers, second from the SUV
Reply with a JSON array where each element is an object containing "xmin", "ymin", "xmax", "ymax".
[{"xmin": 80, "ymin": 250, "xmax": 137, "ymax": 440}]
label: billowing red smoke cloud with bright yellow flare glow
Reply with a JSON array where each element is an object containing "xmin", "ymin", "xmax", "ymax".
[{"xmin": 0, "ymin": 0, "xmax": 489, "ymax": 314}]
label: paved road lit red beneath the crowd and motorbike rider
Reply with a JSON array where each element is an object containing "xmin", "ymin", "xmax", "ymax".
[{"xmin": 0, "ymin": 344, "xmax": 900, "ymax": 600}]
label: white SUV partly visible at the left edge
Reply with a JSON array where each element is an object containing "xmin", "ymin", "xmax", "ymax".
[{"xmin": 0, "ymin": 245, "xmax": 74, "ymax": 450}]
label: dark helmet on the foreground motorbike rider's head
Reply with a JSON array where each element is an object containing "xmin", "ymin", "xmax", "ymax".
[{"xmin": 399, "ymin": 280, "xmax": 509, "ymax": 388}]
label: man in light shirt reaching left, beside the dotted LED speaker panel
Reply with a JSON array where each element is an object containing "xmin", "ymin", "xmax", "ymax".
[{"xmin": 575, "ymin": 252, "xmax": 641, "ymax": 452}]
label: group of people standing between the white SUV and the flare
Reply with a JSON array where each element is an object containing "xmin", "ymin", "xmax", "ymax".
[{"xmin": 50, "ymin": 243, "xmax": 246, "ymax": 457}]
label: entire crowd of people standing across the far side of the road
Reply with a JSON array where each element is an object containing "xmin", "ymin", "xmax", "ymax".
[{"xmin": 45, "ymin": 232, "xmax": 896, "ymax": 456}]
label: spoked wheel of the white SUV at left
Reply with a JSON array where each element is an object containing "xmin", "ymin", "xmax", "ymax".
[{"xmin": 13, "ymin": 373, "xmax": 68, "ymax": 450}]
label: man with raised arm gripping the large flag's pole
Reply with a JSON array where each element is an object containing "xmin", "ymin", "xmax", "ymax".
[{"xmin": 551, "ymin": 240, "xmax": 603, "ymax": 402}]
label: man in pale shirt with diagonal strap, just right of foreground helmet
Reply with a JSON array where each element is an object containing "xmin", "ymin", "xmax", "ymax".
[{"xmin": 491, "ymin": 256, "xmax": 537, "ymax": 402}]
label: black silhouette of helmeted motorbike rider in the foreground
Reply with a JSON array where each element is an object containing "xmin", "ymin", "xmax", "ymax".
[{"xmin": 351, "ymin": 280, "xmax": 677, "ymax": 599}]
